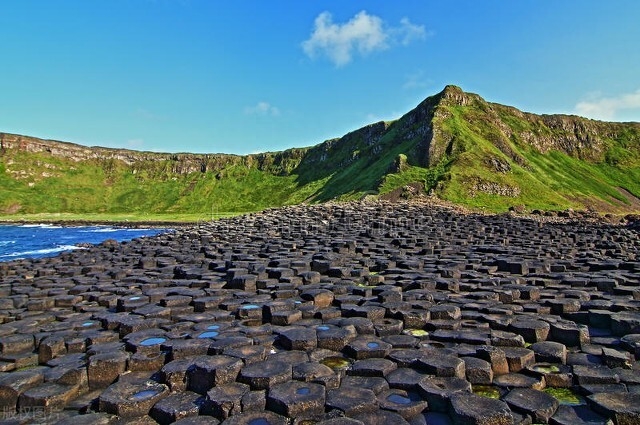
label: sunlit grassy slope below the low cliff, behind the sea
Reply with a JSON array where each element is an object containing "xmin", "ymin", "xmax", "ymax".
[{"xmin": 0, "ymin": 152, "xmax": 304, "ymax": 216}]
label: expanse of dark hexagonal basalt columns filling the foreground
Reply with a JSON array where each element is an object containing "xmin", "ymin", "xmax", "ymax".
[{"xmin": 0, "ymin": 203, "xmax": 640, "ymax": 424}]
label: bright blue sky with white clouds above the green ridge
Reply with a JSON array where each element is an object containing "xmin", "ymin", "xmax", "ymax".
[{"xmin": 0, "ymin": 0, "xmax": 640, "ymax": 154}]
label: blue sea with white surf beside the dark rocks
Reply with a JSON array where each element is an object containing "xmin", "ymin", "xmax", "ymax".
[{"xmin": 0, "ymin": 224, "xmax": 170, "ymax": 262}]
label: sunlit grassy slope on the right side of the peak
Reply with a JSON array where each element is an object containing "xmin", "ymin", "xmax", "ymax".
[{"xmin": 438, "ymin": 101, "xmax": 640, "ymax": 211}]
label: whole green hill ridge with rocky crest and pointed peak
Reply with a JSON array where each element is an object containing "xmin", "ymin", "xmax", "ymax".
[{"xmin": 0, "ymin": 86, "xmax": 640, "ymax": 219}]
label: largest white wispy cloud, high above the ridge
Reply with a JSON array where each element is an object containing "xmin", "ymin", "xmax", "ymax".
[{"xmin": 302, "ymin": 10, "xmax": 428, "ymax": 67}]
